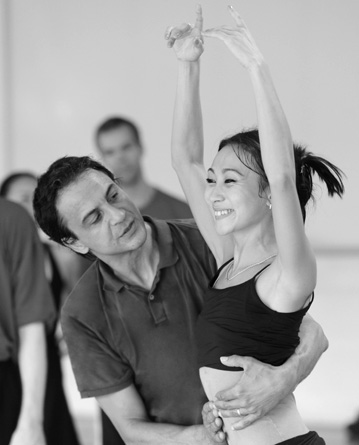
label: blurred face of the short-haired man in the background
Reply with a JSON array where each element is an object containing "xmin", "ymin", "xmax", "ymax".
[{"xmin": 98, "ymin": 125, "xmax": 142, "ymax": 186}]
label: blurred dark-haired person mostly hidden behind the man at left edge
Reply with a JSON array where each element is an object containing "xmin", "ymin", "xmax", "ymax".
[{"xmin": 0, "ymin": 171, "xmax": 83, "ymax": 445}]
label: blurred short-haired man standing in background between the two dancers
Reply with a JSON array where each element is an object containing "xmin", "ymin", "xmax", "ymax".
[{"xmin": 95, "ymin": 116, "xmax": 192, "ymax": 219}]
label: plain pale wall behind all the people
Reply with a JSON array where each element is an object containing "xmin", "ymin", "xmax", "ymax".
[{"xmin": 0, "ymin": 0, "xmax": 359, "ymax": 430}]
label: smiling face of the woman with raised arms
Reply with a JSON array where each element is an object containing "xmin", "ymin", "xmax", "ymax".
[{"xmin": 205, "ymin": 146, "xmax": 268, "ymax": 235}]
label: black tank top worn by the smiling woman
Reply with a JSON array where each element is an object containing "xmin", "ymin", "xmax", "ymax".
[{"xmin": 196, "ymin": 263, "xmax": 313, "ymax": 371}]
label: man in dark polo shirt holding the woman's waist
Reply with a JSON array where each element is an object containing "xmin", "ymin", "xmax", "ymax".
[{"xmin": 34, "ymin": 157, "xmax": 327, "ymax": 445}]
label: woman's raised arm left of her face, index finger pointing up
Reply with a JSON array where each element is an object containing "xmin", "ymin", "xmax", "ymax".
[{"xmin": 165, "ymin": 5, "xmax": 233, "ymax": 264}]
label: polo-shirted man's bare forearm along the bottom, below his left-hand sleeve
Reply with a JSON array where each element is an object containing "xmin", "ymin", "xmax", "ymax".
[{"xmin": 97, "ymin": 385, "xmax": 226, "ymax": 445}]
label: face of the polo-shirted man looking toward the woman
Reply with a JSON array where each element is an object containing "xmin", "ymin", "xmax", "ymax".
[{"xmin": 56, "ymin": 170, "xmax": 146, "ymax": 263}]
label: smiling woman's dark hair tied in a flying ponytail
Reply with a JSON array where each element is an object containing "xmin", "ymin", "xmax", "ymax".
[{"xmin": 218, "ymin": 128, "xmax": 344, "ymax": 221}]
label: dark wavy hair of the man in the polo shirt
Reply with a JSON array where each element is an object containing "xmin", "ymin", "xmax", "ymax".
[{"xmin": 33, "ymin": 156, "xmax": 115, "ymax": 250}]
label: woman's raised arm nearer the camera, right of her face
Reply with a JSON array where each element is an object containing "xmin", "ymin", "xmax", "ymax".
[{"xmin": 203, "ymin": 7, "xmax": 316, "ymax": 311}]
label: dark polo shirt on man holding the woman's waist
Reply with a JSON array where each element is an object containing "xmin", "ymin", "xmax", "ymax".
[{"xmin": 62, "ymin": 218, "xmax": 216, "ymax": 425}]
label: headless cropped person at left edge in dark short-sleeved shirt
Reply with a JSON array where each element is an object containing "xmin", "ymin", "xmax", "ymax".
[{"xmin": 0, "ymin": 198, "xmax": 55, "ymax": 445}]
